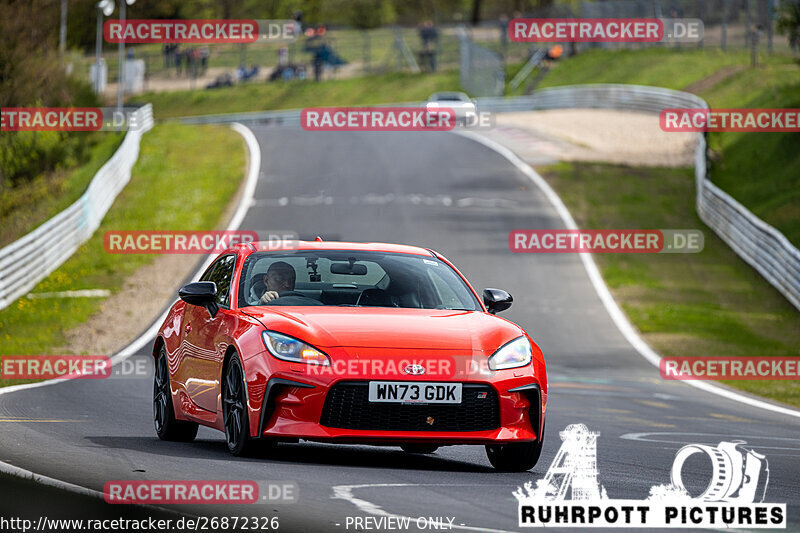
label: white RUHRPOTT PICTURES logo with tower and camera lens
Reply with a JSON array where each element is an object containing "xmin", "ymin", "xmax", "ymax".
[{"xmin": 514, "ymin": 424, "xmax": 786, "ymax": 529}]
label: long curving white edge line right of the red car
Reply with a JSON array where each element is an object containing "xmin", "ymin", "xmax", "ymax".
[{"xmin": 453, "ymin": 131, "xmax": 800, "ymax": 418}]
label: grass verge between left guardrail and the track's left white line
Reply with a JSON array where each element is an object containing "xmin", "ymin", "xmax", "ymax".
[{"xmin": 0, "ymin": 124, "xmax": 246, "ymax": 374}]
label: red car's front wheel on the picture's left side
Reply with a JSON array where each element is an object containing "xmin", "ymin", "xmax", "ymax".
[{"xmin": 222, "ymin": 352, "xmax": 255, "ymax": 457}]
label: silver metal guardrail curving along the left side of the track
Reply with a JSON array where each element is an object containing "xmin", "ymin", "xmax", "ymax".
[{"xmin": 0, "ymin": 104, "xmax": 153, "ymax": 309}]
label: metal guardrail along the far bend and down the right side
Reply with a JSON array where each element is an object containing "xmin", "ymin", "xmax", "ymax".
[{"xmin": 179, "ymin": 84, "xmax": 800, "ymax": 310}]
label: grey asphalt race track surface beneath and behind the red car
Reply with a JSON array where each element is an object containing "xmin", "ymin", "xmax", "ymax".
[{"xmin": 0, "ymin": 127, "xmax": 800, "ymax": 531}]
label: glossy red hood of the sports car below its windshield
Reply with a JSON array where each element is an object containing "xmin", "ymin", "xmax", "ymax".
[{"xmin": 243, "ymin": 306, "xmax": 524, "ymax": 353}]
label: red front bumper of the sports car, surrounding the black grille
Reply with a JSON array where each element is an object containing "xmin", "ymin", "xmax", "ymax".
[{"xmin": 248, "ymin": 352, "xmax": 547, "ymax": 445}]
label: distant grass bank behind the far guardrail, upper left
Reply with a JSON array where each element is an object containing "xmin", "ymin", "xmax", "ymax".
[{"xmin": 136, "ymin": 71, "xmax": 459, "ymax": 119}]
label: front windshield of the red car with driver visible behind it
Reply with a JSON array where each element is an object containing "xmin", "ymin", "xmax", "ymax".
[{"xmin": 234, "ymin": 250, "xmax": 481, "ymax": 311}]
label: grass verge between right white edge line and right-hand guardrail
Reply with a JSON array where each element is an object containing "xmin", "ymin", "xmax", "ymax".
[{"xmin": 540, "ymin": 163, "xmax": 800, "ymax": 406}]
